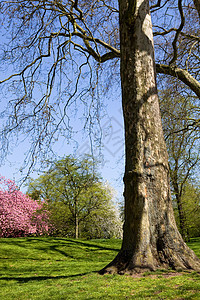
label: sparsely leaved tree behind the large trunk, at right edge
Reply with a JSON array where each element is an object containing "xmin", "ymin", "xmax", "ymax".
[{"xmin": 160, "ymin": 88, "xmax": 200, "ymax": 241}]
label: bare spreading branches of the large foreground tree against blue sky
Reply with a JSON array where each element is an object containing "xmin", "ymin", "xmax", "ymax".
[{"xmin": 0, "ymin": 0, "xmax": 200, "ymax": 169}]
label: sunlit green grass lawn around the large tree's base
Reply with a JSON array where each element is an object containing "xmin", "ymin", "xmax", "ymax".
[{"xmin": 0, "ymin": 238, "xmax": 200, "ymax": 300}]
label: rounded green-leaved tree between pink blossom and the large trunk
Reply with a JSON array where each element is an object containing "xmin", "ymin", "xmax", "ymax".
[{"xmin": 28, "ymin": 156, "xmax": 121, "ymax": 238}]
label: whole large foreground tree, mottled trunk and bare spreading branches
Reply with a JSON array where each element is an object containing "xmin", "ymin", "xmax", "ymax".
[{"xmin": 1, "ymin": 0, "xmax": 200, "ymax": 273}]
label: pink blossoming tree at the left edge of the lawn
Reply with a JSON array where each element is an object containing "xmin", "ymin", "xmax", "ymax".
[{"xmin": 0, "ymin": 176, "xmax": 49, "ymax": 237}]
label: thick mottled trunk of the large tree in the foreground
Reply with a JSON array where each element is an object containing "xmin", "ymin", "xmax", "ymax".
[{"xmin": 100, "ymin": 0, "xmax": 200, "ymax": 274}]
